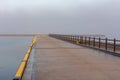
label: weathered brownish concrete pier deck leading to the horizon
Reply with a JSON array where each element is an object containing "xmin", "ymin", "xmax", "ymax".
[{"xmin": 33, "ymin": 35, "xmax": 120, "ymax": 80}]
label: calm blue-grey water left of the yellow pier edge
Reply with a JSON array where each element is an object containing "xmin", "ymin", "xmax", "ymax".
[{"xmin": 0, "ymin": 37, "xmax": 33, "ymax": 80}]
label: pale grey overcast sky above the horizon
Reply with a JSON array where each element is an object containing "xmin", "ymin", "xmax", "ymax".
[{"xmin": 0, "ymin": 0, "xmax": 120, "ymax": 37}]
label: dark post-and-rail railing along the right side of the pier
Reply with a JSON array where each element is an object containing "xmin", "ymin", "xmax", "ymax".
[{"xmin": 49, "ymin": 34, "xmax": 120, "ymax": 53}]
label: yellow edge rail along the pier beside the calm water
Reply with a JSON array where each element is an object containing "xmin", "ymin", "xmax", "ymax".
[{"xmin": 13, "ymin": 36, "xmax": 36, "ymax": 80}]
